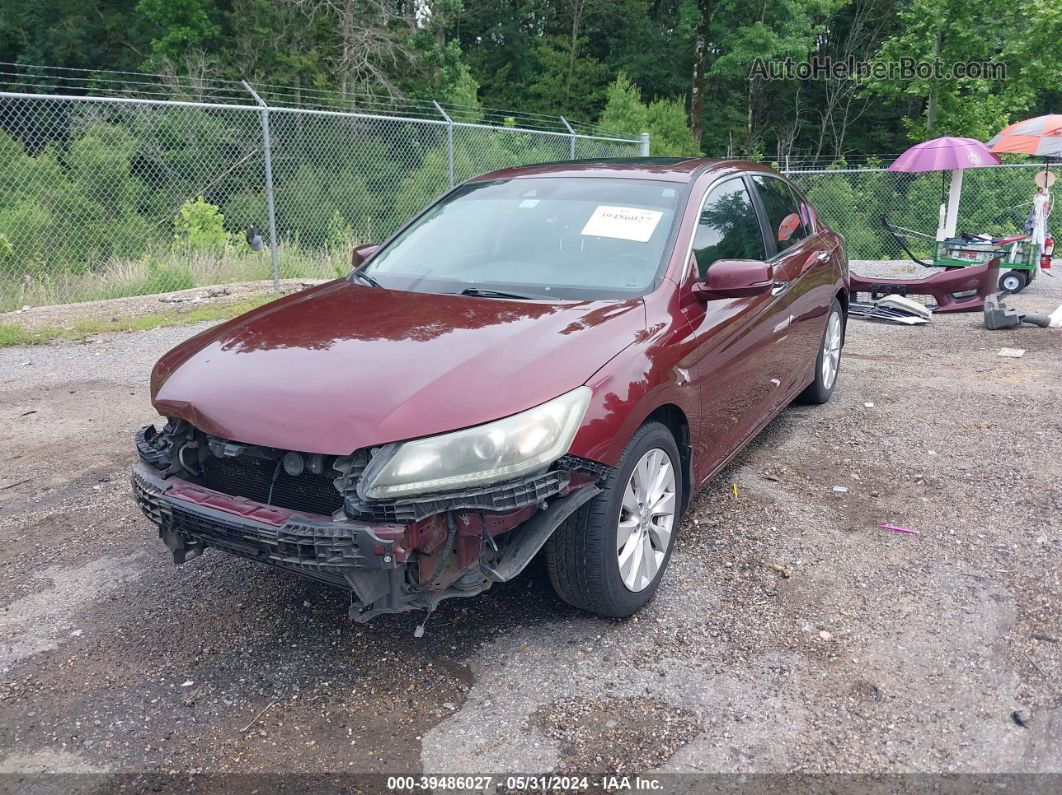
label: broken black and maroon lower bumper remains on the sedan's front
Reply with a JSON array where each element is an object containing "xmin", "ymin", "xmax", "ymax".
[{"xmin": 132, "ymin": 462, "xmax": 600, "ymax": 621}]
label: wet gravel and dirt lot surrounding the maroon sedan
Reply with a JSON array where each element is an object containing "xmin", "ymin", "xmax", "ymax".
[{"xmin": 0, "ymin": 268, "xmax": 1062, "ymax": 792}]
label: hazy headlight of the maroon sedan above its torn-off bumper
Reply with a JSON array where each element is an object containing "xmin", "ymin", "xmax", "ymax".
[{"xmin": 358, "ymin": 386, "xmax": 590, "ymax": 500}]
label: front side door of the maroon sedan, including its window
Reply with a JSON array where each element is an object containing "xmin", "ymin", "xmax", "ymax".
[{"xmin": 684, "ymin": 176, "xmax": 789, "ymax": 477}]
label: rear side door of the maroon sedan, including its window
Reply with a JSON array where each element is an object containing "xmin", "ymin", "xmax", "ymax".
[{"xmin": 751, "ymin": 174, "xmax": 834, "ymax": 399}]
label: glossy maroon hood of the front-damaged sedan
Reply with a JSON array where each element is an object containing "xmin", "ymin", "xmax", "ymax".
[{"xmin": 151, "ymin": 280, "xmax": 645, "ymax": 455}]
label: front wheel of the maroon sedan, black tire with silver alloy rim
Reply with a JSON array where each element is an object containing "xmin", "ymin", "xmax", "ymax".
[{"xmin": 546, "ymin": 422, "xmax": 684, "ymax": 618}]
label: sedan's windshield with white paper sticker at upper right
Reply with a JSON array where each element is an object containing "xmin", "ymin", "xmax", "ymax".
[{"xmin": 363, "ymin": 177, "xmax": 682, "ymax": 299}]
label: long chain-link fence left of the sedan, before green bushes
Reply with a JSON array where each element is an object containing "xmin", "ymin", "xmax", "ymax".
[{"xmin": 0, "ymin": 87, "xmax": 646, "ymax": 311}]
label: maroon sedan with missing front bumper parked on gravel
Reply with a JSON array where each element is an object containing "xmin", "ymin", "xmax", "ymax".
[{"xmin": 133, "ymin": 158, "xmax": 849, "ymax": 621}]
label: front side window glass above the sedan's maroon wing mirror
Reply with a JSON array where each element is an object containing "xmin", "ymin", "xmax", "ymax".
[{"xmin": 693, "ymin": 177, "xmax": 767, "ymax": 279}]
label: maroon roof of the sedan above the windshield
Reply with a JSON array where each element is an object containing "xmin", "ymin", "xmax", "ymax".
[{"xmin": 470, "ymin": 157, "xmax": 771, "ymax": 183}]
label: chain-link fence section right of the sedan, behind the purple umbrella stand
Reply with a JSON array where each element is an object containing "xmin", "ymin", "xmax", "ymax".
[{"xmin": 785, "ymin": 162, "xmax": 1044, "ymax": 260}]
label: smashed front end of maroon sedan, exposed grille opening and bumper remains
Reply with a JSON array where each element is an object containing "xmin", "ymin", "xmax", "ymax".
[{"xmin": 132, "ymin": 396, "xmax": 609, "ymax": 622}]
